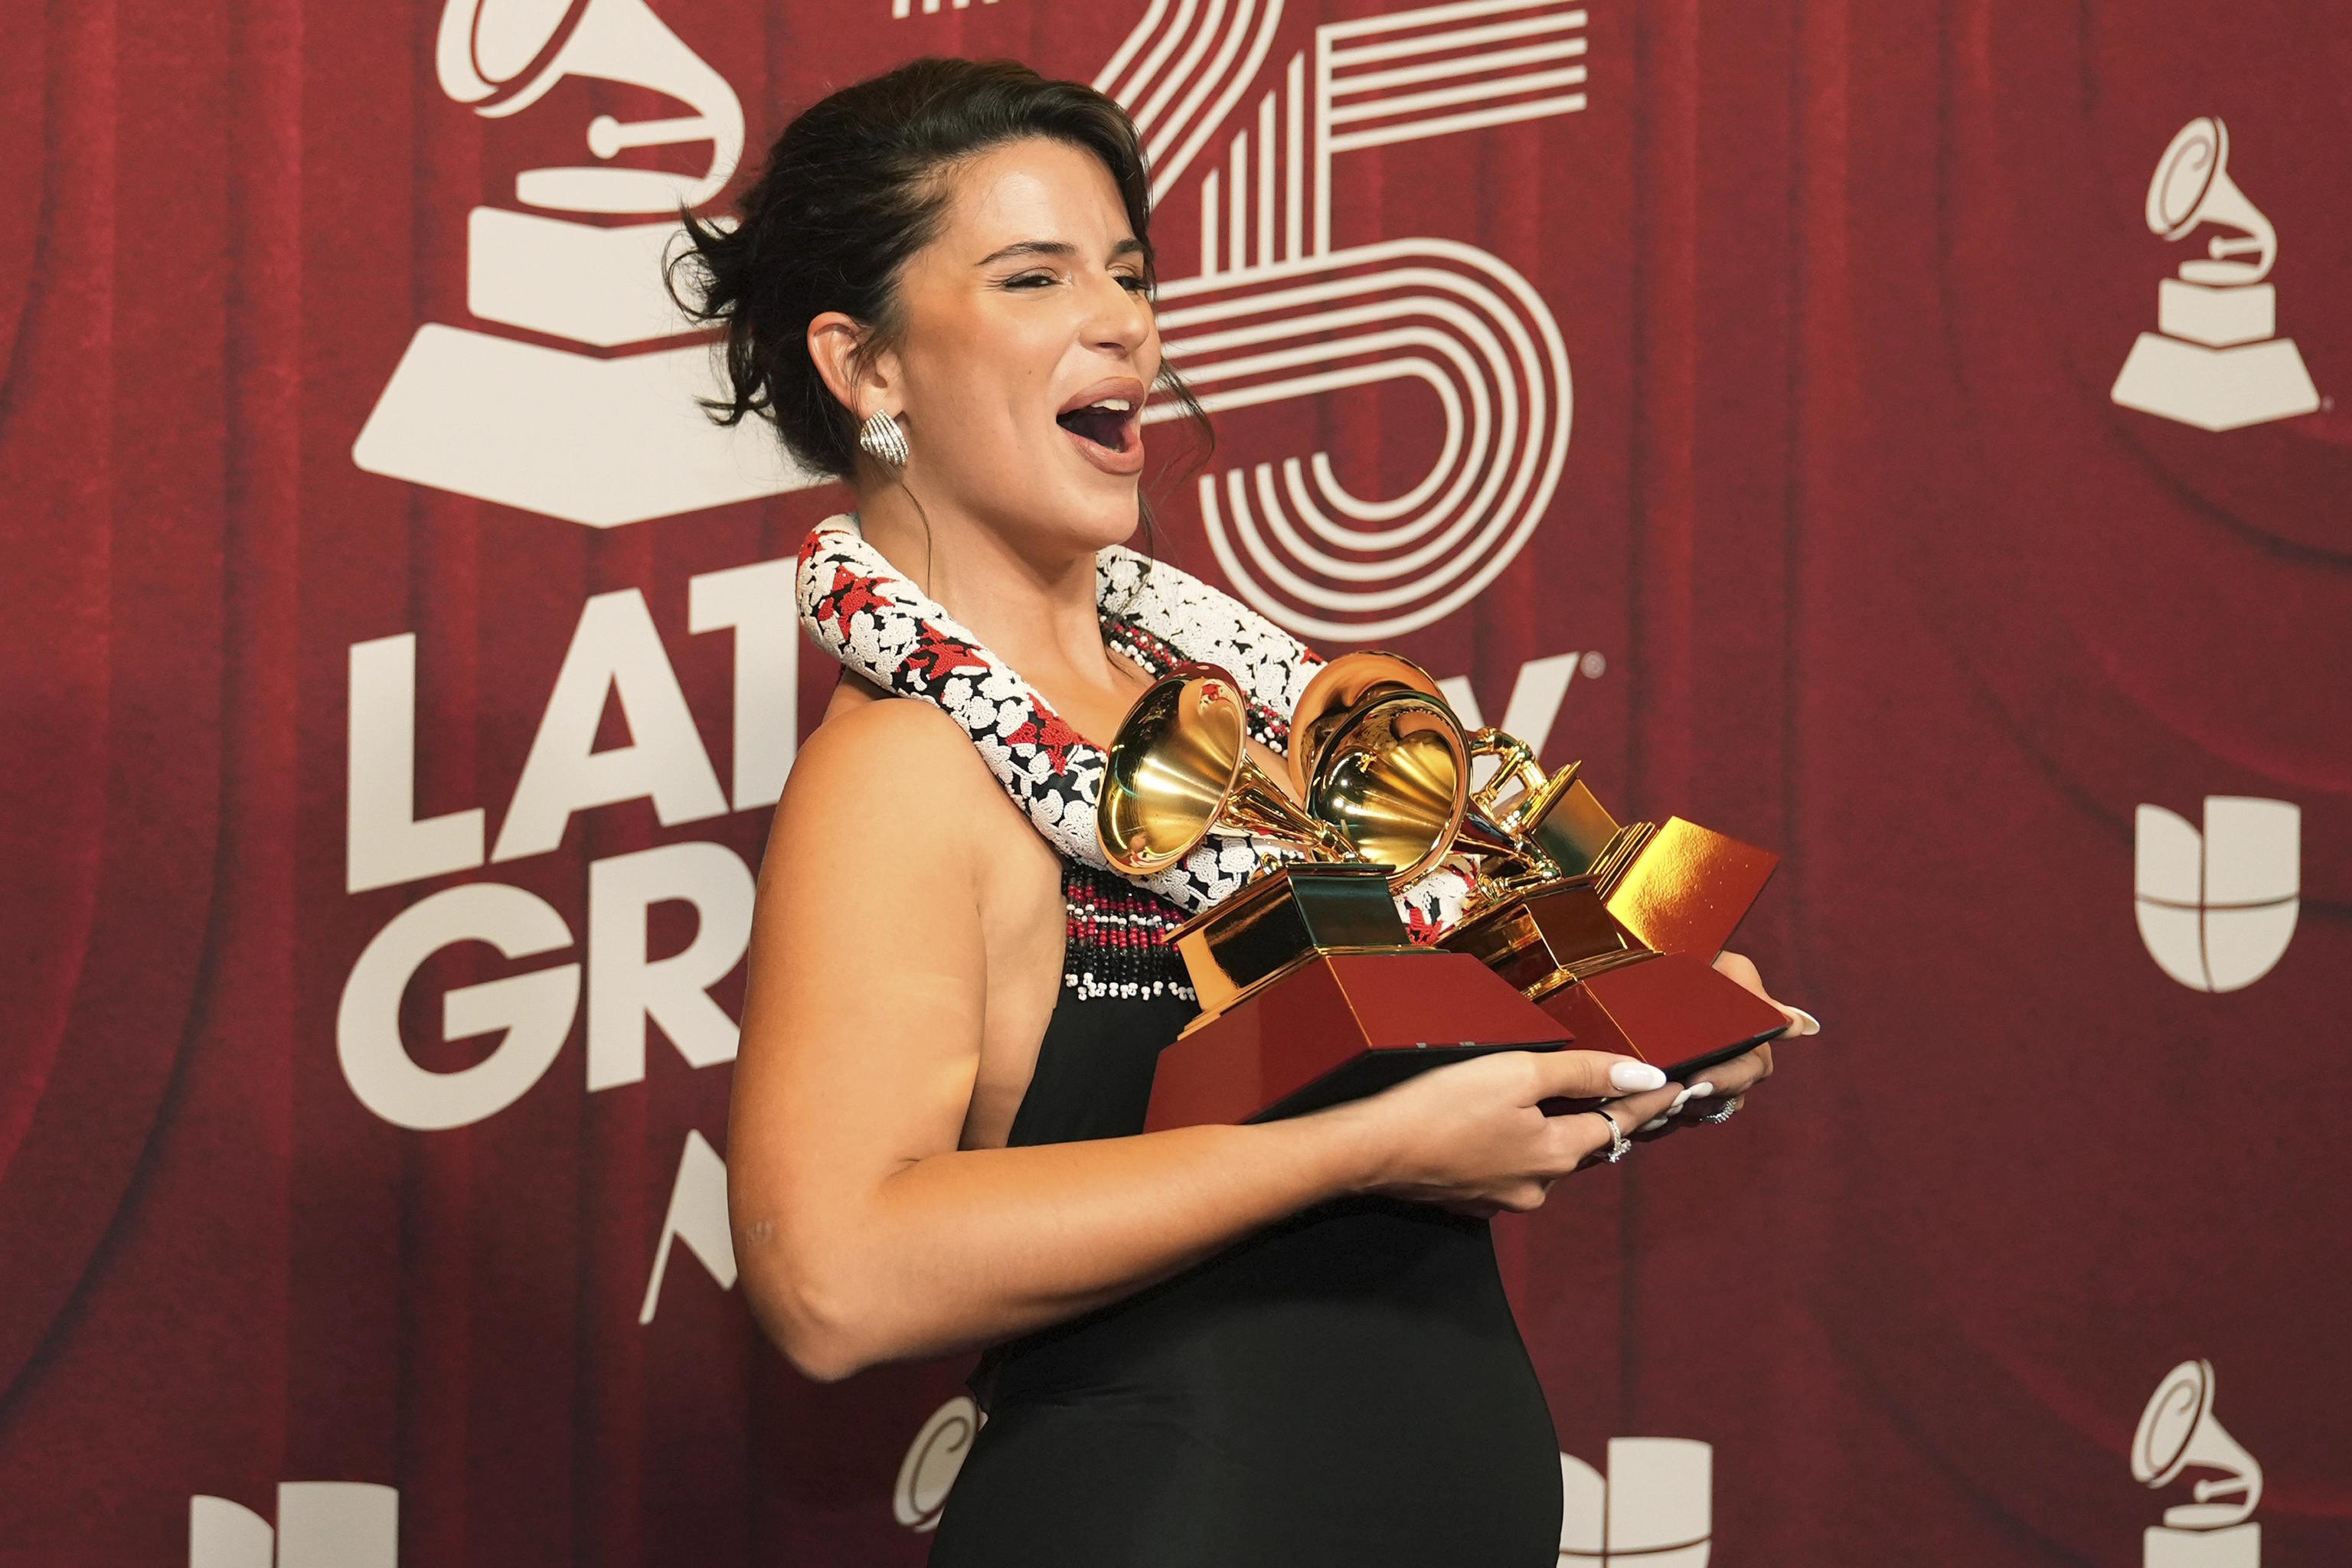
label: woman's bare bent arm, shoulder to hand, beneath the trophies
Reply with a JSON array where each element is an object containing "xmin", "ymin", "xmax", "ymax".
[{"xmin": 727, "ymin": 701, "xmax": 1672, "ymax": 1380}]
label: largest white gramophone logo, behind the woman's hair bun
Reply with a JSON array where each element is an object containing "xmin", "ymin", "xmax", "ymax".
[{"xmin": 351, "ymin": 0, "xmax": 816, "ymax": 529}]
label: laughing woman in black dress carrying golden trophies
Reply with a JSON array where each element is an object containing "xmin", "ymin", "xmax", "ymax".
[{"xmin": 689, "ymin": 59, "xmax": 1771, "ymax": 1568}]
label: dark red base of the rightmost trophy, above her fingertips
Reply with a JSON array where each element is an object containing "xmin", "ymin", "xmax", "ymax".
[{"xmin": 1536, "ymin": 952, "xmax": 1788, "ymax": 1083}]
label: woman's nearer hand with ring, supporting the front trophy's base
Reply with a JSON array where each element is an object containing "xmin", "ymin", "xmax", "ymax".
[{"xmin": 1317, "ymin": 1050, "xmax": 1681, "ymax": 1215}]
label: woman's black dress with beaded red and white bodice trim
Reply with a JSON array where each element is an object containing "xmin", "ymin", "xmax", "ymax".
[{"xmin": 929, "ymin": 865, "xmax": 1560, "ymax": 1568}]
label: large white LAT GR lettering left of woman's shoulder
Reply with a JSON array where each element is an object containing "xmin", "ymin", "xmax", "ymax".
[{"xmin": 336, "ymin": 557, "xmax": 799, "ymax": 1132}]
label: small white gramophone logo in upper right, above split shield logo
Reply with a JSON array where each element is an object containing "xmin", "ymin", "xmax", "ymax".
[{"xmin": 2112, "ymin": 118, "xmax": 2319, "ymax": 430}]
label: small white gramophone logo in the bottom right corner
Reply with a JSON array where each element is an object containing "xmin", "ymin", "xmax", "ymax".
[{"xmin": 2131, "ymin": 1361, "xmax": 2262, "ymax": 1568}]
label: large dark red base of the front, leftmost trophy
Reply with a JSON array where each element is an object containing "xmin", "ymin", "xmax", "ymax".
[{"xmin": 1143, "ymin": 947, "xmax": 1571, "ymax": 1133}]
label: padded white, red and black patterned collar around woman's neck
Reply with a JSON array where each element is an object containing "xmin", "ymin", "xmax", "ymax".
[{"xmin": 797, "ymin": 512, "xmax": 1465, "ymax": 936}]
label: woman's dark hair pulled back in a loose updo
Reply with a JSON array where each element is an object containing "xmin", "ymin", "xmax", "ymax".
[{"xmin": 671, "ymin": 57, "xmax": 1214, "ymax": 524}]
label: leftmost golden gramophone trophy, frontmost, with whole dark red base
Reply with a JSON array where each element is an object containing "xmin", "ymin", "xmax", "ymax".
[{"xmin": 1096, "ymin": 665, "xmax": 1569, "ymax": 1131}]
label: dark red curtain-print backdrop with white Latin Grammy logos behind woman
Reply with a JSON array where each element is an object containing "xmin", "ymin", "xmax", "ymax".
[{"xmin": 0, "ymin": 0, "xmax": 2352, "ymax": 1568}]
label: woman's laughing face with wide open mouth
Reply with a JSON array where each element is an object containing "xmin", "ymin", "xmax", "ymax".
[{"xmin": 877, "ymin": 136, "xmax": 1159, "ymax": 555}]
